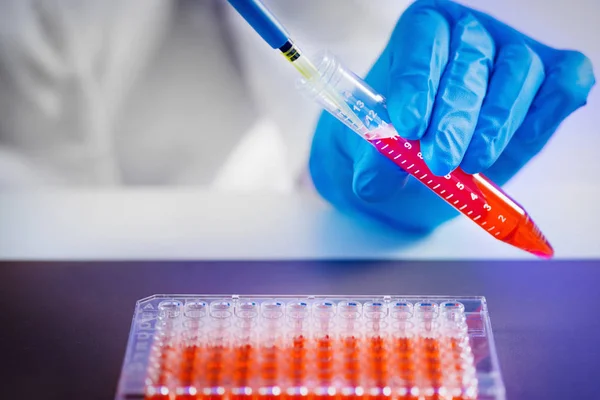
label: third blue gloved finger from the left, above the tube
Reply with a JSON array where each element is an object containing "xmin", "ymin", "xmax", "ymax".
[{"xmin": 461, "ymin": 44, "xmax": 545, "ymax": 174}]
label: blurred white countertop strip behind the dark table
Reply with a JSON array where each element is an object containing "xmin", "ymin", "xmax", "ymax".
[{"xmin": 0, "ymin": 185, "xmax": 600, "ymax": 260}]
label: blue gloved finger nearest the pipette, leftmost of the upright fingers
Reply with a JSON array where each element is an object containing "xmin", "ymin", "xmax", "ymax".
[{"xmin": 387, "ymin": 4, "xmax": 450, "ymax": 140}]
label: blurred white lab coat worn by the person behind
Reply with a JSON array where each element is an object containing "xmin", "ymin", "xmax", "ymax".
[{"xmin": 0, "ymin": 0, "xmax": 406, "ymax": 191}]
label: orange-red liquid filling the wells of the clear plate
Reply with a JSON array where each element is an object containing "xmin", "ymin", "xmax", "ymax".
[{"xmin": 141, "ymin": 322, "xmax": 477, "ymax": 400}]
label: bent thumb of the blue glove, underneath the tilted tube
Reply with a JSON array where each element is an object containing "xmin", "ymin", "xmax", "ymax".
[{"xmin": 352, "ymin": 141, "xmax": 409, "ymax": 203}]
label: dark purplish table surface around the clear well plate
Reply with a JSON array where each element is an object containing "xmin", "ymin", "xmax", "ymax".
[{"xmin": 0, "ymin": 261, "xmax": 600, "ymax": 400}]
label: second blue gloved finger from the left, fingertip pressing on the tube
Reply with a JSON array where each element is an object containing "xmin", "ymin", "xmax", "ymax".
[{"xmin": 421, "ymin": 14, "xmax": 495, "ymax": 176}]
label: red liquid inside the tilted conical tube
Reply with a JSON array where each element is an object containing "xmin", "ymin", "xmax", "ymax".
[{"xmin": 369, "ymin": 128, "xmax": 554, "ymax": 258}]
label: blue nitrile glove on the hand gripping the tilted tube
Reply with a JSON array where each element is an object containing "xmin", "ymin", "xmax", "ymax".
[{"xmin": 310, "ymin": 0, "xmax": 595, "ymax": 234}]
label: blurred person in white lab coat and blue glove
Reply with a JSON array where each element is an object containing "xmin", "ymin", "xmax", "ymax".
[{"xmin": 0, "ymin": 0, "xmax": 595, "ymax": 236}]
